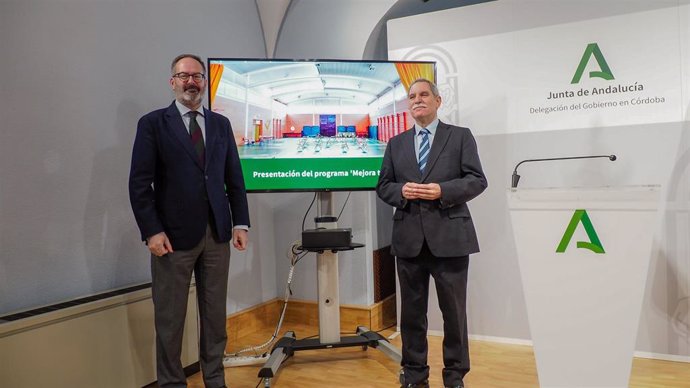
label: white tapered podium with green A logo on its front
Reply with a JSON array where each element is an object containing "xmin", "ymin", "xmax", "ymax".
[{"xmin": 508, "ymin": 186, "xmax": 660, "ymax": 388}]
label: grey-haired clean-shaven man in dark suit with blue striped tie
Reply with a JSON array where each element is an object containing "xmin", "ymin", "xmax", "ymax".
[{"xmin": 376, "ymin": 79, "xmax": 487, "ymax": 388}]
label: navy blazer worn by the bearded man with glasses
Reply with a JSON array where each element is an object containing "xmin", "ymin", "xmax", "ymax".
[{"xmin": 129, "ymin": 102, "xmax": 249, "ymax": 250}]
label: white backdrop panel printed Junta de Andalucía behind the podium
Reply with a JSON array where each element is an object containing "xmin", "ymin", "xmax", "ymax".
[{"xmin": 388, "ymin": 0, "xmax": 690, "ymax": 359}]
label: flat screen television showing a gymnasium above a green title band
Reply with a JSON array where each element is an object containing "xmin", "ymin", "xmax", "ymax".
[{"xmin": 208, "ymin": 58, "xmax": 436, "ymax": 192}]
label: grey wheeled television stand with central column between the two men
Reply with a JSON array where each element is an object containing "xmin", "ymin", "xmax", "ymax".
[{"xmin": 258, "ymin": 192, "xmax": 402, "ymax": 388}]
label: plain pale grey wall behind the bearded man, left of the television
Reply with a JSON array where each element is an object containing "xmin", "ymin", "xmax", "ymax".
[{"xmin": 0, "ymin": 0, "xmax": 268, "ymax": 314}]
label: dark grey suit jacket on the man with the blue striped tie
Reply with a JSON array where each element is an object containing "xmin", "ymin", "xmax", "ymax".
[{"xmin": 376, "ymin": 122, "xmax": 487, "ymax": 257}]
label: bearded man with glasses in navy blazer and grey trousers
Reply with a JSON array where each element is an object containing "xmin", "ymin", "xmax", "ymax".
[{"xmin": 129, "ymin": 54, "xmax": 249, "ymax": 388}]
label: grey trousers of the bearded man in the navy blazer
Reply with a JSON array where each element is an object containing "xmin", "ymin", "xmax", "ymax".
[{"xmin": 151, "ymin": 227, "xmax": 230, "ymax": 388}]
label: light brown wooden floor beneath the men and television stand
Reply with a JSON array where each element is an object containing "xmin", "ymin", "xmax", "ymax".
[{"xmin": 188, "ymin": 324, "xmax": 690, "ymax": 388}]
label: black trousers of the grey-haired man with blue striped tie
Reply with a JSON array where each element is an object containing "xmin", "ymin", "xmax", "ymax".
[{"xmin": 397, "ymin": 242, "xmax": 470, "ymax": 386}]
